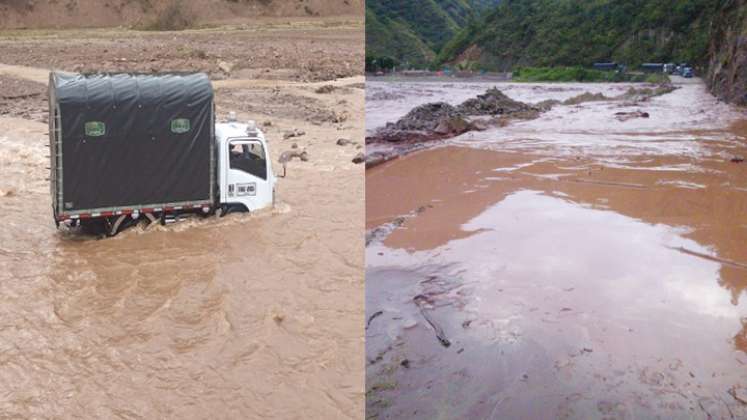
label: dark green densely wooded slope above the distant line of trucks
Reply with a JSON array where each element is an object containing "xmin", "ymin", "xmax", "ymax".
[{"xmin": 436, "ymin": 0, "xmax": 723, "ymax": 70}]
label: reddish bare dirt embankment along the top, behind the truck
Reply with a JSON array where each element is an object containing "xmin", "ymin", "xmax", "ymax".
[{"xmin": 0, "ymin": 0, "xmax": 363, "ymax": 29}]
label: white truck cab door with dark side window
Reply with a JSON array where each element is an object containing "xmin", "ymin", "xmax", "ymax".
[{"xmin": 226, "ymin": 139, "xmax": 273, "ymax": 211}]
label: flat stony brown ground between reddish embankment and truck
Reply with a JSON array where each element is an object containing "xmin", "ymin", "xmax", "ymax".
[{"xmin": 0, "ymin": 19, "xmax": 363, "ymax": 82}]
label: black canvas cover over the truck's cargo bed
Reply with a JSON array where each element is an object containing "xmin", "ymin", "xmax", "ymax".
[{"xmin": 50, "ymin": 73, "xmax": 214, "ymax": 213}]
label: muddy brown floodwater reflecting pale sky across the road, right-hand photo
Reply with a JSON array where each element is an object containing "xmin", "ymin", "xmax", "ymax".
[{"xmin": 366, "ymin": 78, "xmax": 747, "ymax": 419}]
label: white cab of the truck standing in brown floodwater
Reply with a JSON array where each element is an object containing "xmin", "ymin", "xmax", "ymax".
[{"xmin": 215, "ymin": 116, "xmax": 277, "ymax": 215}]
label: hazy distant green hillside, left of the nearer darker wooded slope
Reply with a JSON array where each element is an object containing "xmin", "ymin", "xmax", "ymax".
[{"xmin": 366, "ymin": 0, "xmax": 498, "ymax": 70}]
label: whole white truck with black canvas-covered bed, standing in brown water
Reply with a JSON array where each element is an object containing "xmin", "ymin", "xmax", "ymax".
[{"xmin": 49, "ymin": 72, "xmax": 277, "ymax": 236}]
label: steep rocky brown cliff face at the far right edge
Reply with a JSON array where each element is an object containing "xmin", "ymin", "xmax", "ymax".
[{"xmin": 706, "ymin": 0, "xmax": 747, "ymax": 106}]
